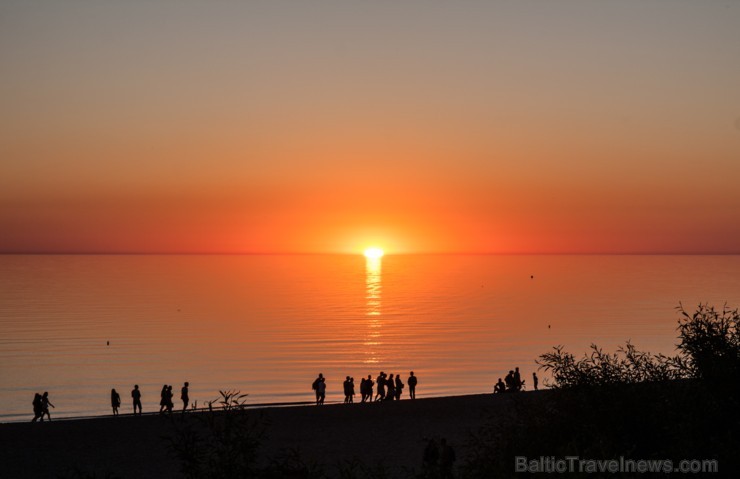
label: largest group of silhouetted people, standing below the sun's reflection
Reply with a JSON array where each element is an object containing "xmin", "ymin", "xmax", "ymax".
[{"xmin": 311, "ymin": 371, "xmax": 418, "ymax": 406}]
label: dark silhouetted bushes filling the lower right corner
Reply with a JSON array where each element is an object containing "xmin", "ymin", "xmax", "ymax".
[{"xmin": 461, "ymin": 305, "xmax": 740, "ymax": 477}]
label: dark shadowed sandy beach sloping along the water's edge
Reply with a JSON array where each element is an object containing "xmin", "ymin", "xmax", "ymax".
[{"xmin": 0, "ymin": 391, "xmax": 528, "ymax": 478}]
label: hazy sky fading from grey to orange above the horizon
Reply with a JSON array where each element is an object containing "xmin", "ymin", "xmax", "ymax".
[{"xmin": 0, "ymin": 0, "xmax": 740, "ymax": 254}]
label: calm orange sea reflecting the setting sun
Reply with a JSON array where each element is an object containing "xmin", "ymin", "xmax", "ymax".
[{"xmin": 0, "ymin": 255, "xmax": 740, "ymax": 421}]
